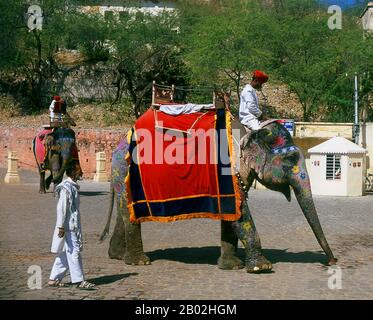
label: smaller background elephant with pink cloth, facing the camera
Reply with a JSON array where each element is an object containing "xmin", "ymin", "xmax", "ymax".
[{"xmin": 32, "ymin": 128, "xmax": 83, "ymax": 193}]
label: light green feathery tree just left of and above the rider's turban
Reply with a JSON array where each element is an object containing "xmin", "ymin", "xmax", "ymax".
[{"xmin": 180, "ymin": 0, "xmax": 270, "ymax": 102}]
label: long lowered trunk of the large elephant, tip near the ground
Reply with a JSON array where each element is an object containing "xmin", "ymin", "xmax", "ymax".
[{"xmin": 293, "ymin": 186, "xmax": 337, "ymax": 265}]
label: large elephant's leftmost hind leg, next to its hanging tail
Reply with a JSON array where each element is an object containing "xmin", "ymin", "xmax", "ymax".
[{"xmin": 108, "ymin": 204, "xmax": 126, "ymax": 260}]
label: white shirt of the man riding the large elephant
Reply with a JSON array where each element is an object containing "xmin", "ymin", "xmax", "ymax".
[{"xmin": 239, "ymin": 84, "xmax": 262, "ymax": 130}]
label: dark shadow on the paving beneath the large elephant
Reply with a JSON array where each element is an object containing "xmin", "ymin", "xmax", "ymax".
[{"xmin": 146, "ymin": 247, "xmax": 327, "ymax": 265}]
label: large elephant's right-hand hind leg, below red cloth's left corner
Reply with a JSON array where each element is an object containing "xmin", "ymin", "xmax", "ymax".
[{"xmin": 121, "ymin": 201, "xmax": 151, "ymax": 265}]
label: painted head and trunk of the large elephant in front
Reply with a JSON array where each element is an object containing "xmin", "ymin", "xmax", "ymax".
[{"xmin": 231, "ymin": 121, "xmax": 337, "ymax": 265}]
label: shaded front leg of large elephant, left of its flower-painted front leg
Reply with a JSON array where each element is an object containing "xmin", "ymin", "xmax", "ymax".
[{"xmin": 218, "ymin": 221, "xmax": 244, "ymax": 270}]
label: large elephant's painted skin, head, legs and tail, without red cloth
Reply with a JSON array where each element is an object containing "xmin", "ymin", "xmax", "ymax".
[{"xmin": 100, "ymin": 123, "xmax": 337, "ymax": 272}]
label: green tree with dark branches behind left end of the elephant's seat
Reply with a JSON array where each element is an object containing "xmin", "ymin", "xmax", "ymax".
[{"xmin": 112, "ymin": 11, "xmax": 185, "ymax": 116}]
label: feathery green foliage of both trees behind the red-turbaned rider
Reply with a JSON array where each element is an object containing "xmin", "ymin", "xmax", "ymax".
[{"xmin": 177, "ymin": 0, "xmax": 373, "ymax": 121}]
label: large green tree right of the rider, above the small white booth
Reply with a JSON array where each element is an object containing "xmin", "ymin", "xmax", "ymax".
[{"xmin": 268, "ymin": 0, "xmax": 373, "ymax": 122}]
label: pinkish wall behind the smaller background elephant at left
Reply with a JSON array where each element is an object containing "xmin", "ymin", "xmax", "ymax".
[{"xmin": 0, "ymin": 127, "xmax": 127, "ymax": 179}]
